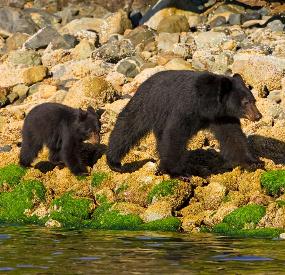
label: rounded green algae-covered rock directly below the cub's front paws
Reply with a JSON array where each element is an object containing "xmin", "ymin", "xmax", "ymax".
[{"xmin": 50, "ymin": 193, "xmax": 92, "ymax": 228}]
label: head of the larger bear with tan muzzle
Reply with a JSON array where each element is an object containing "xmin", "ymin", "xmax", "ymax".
[{"xmin": 218, "ymin": 74, "xmax": 262, "ymax": 121}]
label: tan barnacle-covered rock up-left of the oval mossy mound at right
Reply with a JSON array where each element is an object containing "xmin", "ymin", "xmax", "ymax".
[{"xmin": 195, "ymin": 182, "xmax": 227, "ymax": 210}]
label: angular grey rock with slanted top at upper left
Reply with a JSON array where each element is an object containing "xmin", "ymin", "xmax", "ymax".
[{"xmin": 24, "ymin": 26, "xmax": 64, "ymax": 49}]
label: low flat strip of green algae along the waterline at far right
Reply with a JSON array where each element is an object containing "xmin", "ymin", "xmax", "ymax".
[{"xmin": 212, "ymin": 223, "xmax": 284, "ymax": 238}]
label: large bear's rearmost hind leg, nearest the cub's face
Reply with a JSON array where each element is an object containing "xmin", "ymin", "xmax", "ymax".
[{"xmin": 107, "ymin": 106, "xmax": 151, "ymax": 172}]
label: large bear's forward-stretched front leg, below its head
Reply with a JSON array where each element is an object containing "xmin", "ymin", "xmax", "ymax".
[{"xmin": 211, "ymin": 123, "xmax": 264, "ymax": 168}]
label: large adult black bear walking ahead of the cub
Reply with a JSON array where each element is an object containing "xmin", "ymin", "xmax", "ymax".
[{"xmin": 107, "ymin": 70, "xmax": 262, "ymax": 180}]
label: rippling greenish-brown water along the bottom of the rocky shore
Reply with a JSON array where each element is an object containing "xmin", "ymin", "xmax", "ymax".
[{"xmin": 0, "ymin": 226, "xmax": 285, "ymax": 275}]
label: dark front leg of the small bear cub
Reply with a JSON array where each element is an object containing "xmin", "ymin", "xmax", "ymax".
[{"xmin": 60, "ymin": 134, "xmax": 88, "ymax": 175}]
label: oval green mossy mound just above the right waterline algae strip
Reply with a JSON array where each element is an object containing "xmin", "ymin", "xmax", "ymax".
[{"xmin": 223, "ymin": 204, "xmax": 266, "ymax": 229}]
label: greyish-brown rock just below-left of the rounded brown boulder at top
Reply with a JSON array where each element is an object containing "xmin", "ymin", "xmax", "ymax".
[{"xmin": 125, "ymin": 26, "xmax": 155, "ymax": 47}]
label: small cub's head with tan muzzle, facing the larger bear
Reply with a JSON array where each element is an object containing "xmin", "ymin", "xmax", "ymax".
[{"xmin": 75, "ymin": 106, "xmax": 101, "ymax": 144}]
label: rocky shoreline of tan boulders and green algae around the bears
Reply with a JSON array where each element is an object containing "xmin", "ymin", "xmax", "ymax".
[{"xmin": 0, "ymin": 0, "xmax": 285, "ymax": 237}]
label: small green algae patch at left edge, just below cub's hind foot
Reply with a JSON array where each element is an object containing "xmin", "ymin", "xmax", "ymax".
[{"xmin": 0, "ymin": 164, "xmax": 27, "ymax": 186}]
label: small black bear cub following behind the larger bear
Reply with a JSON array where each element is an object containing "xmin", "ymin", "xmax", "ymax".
[{"xmin": 20, "ymin": 103, "xmax": 100, "ymax": 175}]
